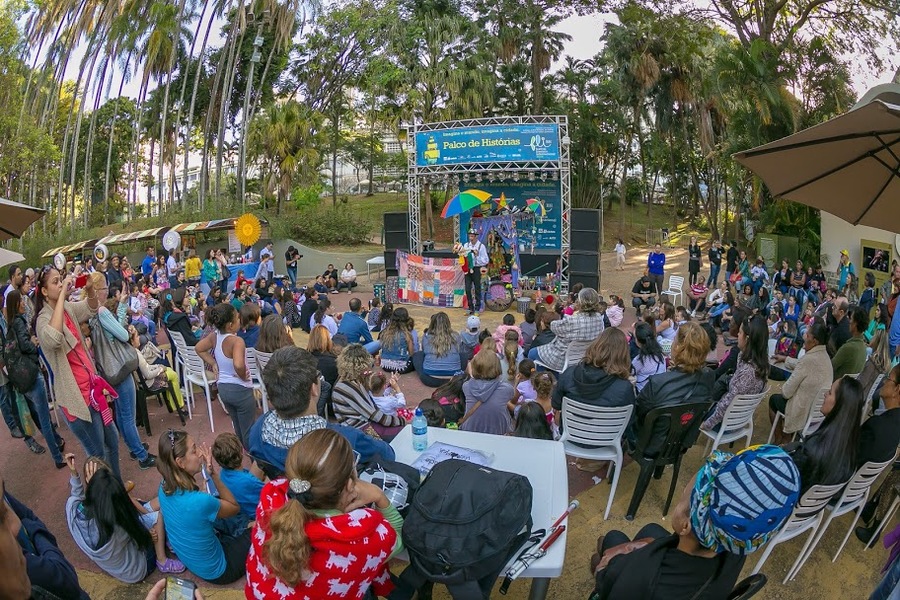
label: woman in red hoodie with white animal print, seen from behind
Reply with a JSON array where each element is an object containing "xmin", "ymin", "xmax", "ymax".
[{"xmin": 244, "ymin": 429, "xmax": 403, "ymax": 600}]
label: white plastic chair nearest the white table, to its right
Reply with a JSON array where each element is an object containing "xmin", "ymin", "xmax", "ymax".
[{"xmin": 559, "ymin": 397, "xmax": 634, "ymax": 520}]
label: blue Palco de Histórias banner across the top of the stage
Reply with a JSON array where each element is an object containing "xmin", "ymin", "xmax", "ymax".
[{"xmin": 416, "ymin": 123, "xmax": 559, "ymax": 167}]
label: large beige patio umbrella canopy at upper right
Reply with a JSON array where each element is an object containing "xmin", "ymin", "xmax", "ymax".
[{"xmin": 734, "ymin": 84, "xmax": 900, "ymax": 233}]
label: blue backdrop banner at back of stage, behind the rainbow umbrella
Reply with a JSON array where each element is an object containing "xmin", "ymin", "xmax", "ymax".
[{"xmin": 459, "ymin": 180, "xmax": 562, "ymax": 254}]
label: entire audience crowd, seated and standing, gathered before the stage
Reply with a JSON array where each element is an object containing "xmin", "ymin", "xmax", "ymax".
[{"xmin": 0, "ymin": 238, "xmax": 900, "ymax": 599}]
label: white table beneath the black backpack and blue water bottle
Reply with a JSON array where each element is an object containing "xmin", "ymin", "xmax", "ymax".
[{"xmin": 391, "ymin": 425, "xmax": 569, "ymax": 579}]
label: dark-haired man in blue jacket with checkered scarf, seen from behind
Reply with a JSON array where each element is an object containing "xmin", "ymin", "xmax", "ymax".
[{"xmin": 250, "ymin": 346, "xmax": 394, "ymax": 474}]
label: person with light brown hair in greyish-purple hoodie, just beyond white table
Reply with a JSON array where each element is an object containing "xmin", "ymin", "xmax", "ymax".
[{"xmin": 459, "ymin": 344, "xmax": 513, "ymax": 435}]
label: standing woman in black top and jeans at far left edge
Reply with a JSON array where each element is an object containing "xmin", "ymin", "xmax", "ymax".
[{"xmin": 6, "ymin": 290, "xmax": 66, "ymax": 469}]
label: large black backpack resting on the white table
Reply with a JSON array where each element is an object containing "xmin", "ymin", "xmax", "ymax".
[{"xmin": 400, "ymin": 459, "xmax": 533, "ymax": 600}]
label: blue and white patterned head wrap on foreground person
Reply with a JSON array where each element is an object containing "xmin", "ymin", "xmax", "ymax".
[{"xmin": 690, "ymin": 445, "xmax": 800, "ymax": 555}]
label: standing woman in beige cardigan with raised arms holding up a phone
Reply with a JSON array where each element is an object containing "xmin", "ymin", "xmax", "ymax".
[{"xmin": 34, "ymin": 266, "xmax": 122, "ymax": 479}]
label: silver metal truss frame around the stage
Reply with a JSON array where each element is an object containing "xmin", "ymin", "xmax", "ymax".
[{"xmin": 406, "ymin": 115, "xmax": 572, "ymax": 294}]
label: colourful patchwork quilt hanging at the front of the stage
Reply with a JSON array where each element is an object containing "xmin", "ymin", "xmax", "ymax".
[{"xmin": 397, "ymin": 250, "xmax": 466, "ymax": 308}]
